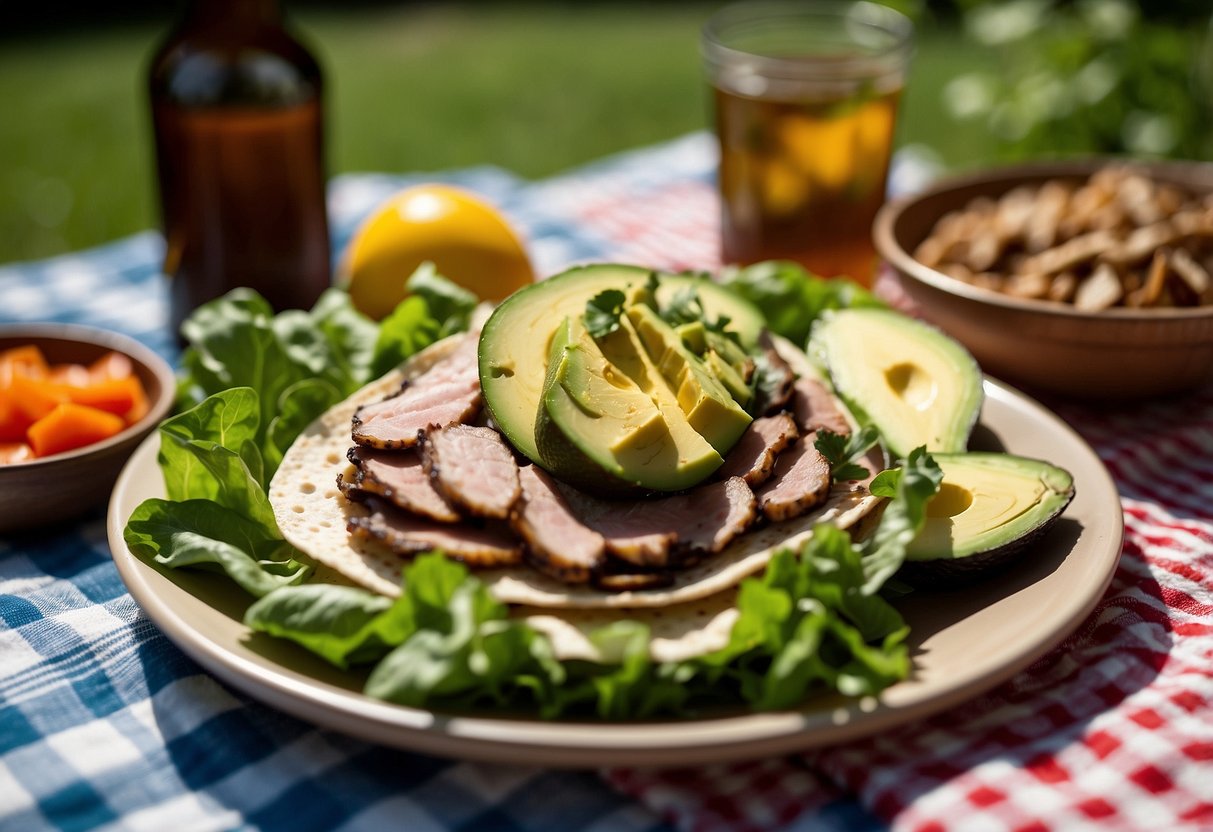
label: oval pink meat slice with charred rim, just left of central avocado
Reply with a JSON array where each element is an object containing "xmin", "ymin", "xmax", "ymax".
[{"xmin": 421, "ymin": 424, "xmax": 522, "ymax": 520}]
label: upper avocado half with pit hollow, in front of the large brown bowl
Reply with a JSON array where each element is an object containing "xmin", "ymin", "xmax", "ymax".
[{"xmin": 809, "ymin": 308, "xmax": 984, "ymax": 458}]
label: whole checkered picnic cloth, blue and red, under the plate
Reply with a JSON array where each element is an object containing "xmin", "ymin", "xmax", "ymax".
[{"xmin": 0, "ymin": 133, "xmax": 1213, "ymax": 831}]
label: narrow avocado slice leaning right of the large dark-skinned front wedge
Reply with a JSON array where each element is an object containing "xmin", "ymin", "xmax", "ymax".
[{"xmin": 626, "ymin": 304, "xmax": 751, "ymax": 456}]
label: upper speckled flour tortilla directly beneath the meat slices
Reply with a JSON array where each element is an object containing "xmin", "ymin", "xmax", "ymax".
[{"xmin": 269, "ymin": 335, "xmax": 881, "ymax": 617}]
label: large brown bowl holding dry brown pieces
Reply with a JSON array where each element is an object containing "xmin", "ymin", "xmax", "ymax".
[{"xmin": 873, "ymin": 159, "xmax": 1213, "ymax": 399}]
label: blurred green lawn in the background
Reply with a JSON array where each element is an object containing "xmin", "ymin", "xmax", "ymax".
[{"xmin": 0, "ymin": 4, "xmax": 989, "ymax": 262}]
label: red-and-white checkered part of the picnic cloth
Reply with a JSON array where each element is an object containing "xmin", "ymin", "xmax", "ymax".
[{"xmin": 549, "ymin": 138, "xmax": 1213, "ymax": 832}]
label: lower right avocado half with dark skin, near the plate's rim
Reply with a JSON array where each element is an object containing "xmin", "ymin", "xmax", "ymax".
[{"xmin": 902, "ymin": 454, "xmax": 1074, "ymax": 583}]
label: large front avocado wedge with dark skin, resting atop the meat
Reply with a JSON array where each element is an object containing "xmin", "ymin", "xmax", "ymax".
[{"xmin": 537, "ymin": 315, "xmax": 724, "ymax": 491}]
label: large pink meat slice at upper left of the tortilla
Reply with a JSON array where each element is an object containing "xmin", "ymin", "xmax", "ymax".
[{"xmin": 352, "ymin": 332, "xmax": 480, "ymax": 448}]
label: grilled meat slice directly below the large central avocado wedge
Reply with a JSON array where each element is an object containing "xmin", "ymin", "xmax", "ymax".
[{"xmin": 560, "ymin": 477, "xmax": 757, "ymax": 569}]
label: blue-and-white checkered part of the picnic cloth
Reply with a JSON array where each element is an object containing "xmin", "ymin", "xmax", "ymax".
[{"xmin": 0, "ymin": 133, "xmax": 881, "ymax": 832}]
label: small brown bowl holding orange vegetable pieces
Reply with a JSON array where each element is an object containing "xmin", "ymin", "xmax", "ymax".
[{"xmin": 0, "ymin": 324, "xmax": 176, "ymax": 534}]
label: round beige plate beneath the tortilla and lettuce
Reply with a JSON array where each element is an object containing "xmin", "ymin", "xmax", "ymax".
[{"xmin": 108, "ymin": 380, "xmax": 1124, "ymax": 767}]
